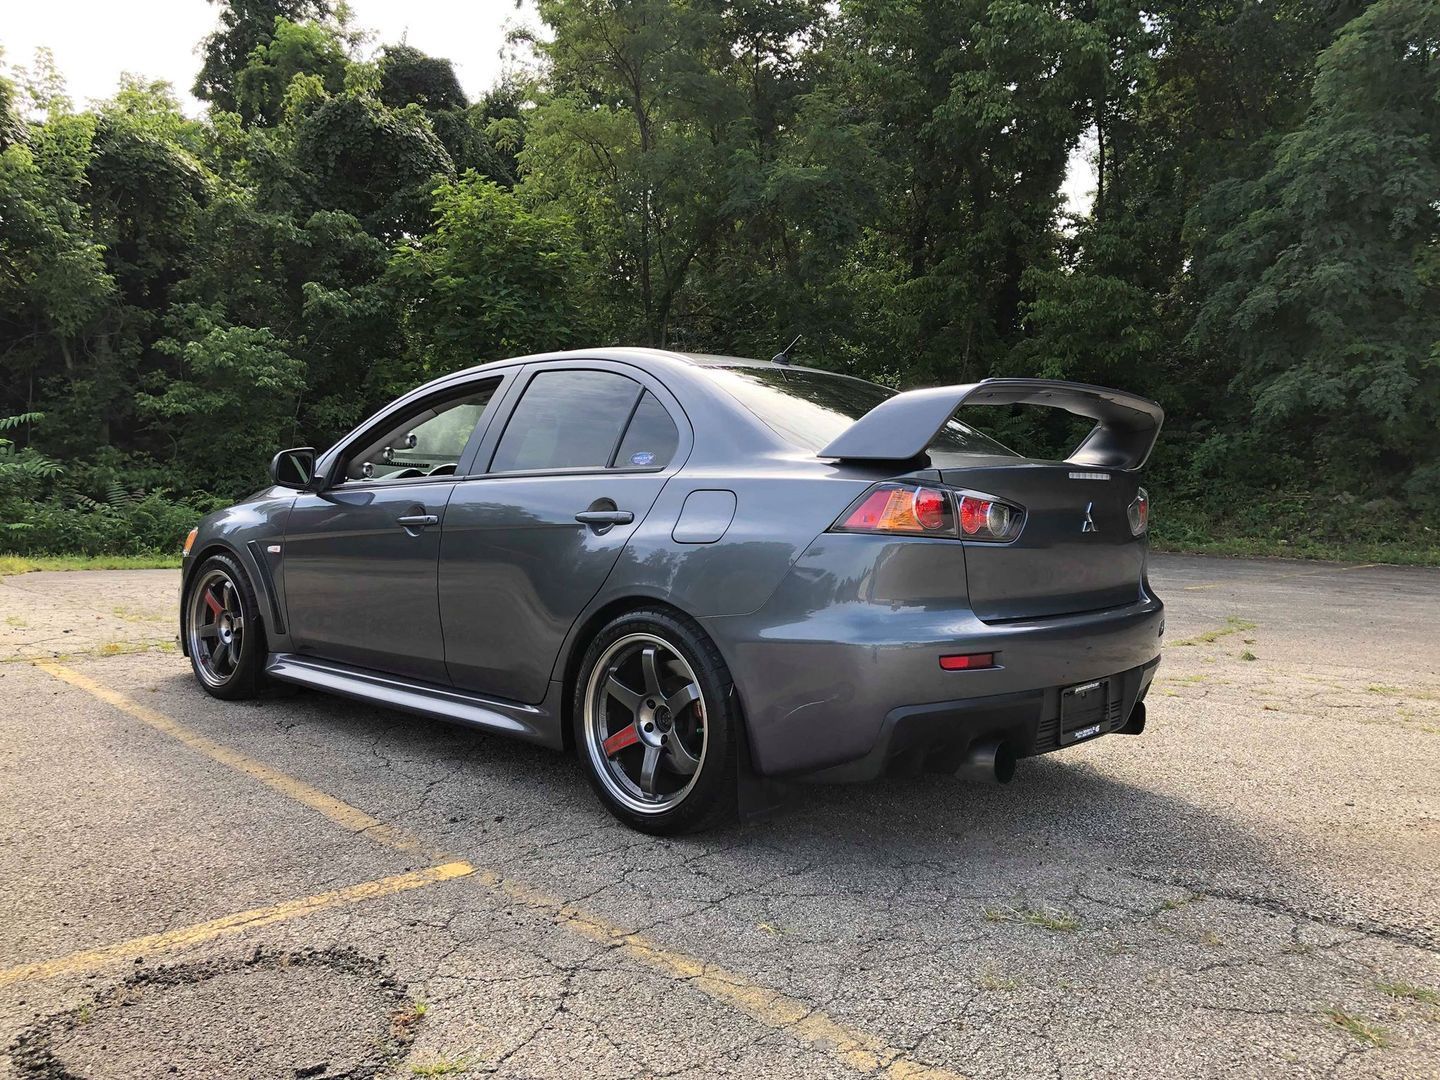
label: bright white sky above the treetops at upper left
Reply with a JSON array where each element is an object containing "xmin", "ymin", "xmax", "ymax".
[{"xmin": 0, "ymin": 0, "xmax": 534, "ymax": 114}]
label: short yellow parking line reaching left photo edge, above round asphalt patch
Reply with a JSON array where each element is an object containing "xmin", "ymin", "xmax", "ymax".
[{"xmin": 0, "ymin": 863, "xmax": 475, "ymax": 986}]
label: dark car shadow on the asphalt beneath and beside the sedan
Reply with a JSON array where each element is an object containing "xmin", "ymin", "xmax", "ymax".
[{"xmin": 157, "ymin": 674, "xmax": 1287, "ymax": 915}]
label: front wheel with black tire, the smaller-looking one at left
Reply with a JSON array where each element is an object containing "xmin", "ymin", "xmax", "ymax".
[{"xmin": 183, "ymin": 554, "xmax": 268, "ymax": 701}]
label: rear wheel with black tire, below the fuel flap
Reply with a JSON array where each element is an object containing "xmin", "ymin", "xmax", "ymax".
[{"xmin": 572, "ymin": 609, "xmax": 743, "ymax": 837}]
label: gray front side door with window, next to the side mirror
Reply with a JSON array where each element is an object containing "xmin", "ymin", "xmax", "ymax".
[{"xmin": 284, "ymin": 377, "xmax": 500, "ymax": 684}]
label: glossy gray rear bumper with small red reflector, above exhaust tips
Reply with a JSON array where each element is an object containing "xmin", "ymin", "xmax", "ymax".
[{"xmin": 701, "ymin": 590, "xmax": 1165, "ymax": 780}]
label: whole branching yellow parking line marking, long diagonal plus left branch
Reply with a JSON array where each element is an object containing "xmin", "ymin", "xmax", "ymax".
[{"xmin": 36, "ymin": 661, "xmax": 963, "ymax": 1080}]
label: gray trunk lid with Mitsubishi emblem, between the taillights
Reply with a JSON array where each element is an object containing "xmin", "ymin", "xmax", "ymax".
[{"xmin": 939, "ymin": 461, "xmax": 1145, "ymax": 622}]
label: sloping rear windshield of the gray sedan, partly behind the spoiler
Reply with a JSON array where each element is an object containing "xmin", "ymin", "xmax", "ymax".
[{"xmin": 706, "ymin": 367, "xmax": 1020, "ymax": 458}]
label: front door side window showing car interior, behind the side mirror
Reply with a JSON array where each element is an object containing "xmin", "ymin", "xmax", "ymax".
[{"xmin": 346, "ymin": 379, "xmax": 500, "ymax": 481}]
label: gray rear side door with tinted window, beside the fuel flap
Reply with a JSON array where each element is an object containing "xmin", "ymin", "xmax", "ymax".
[{"xmin": 439, "ymin": 361, "xmax": 691, "ymax": 703}]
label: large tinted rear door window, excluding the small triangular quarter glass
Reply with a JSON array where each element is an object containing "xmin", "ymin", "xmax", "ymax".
[{"xmin": 490, "ymin": 372, "xmax": 639, "ymax": 472}]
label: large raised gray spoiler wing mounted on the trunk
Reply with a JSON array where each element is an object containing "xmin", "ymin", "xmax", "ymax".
[{"xmin": 816, "ymin": 379, "xmax": 1165, "ymax": 471}]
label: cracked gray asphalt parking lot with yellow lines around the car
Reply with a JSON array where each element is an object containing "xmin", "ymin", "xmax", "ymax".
[{"xmin": 0, "ymin": 556, "xmax": 1440, "ymax": 1080}]
